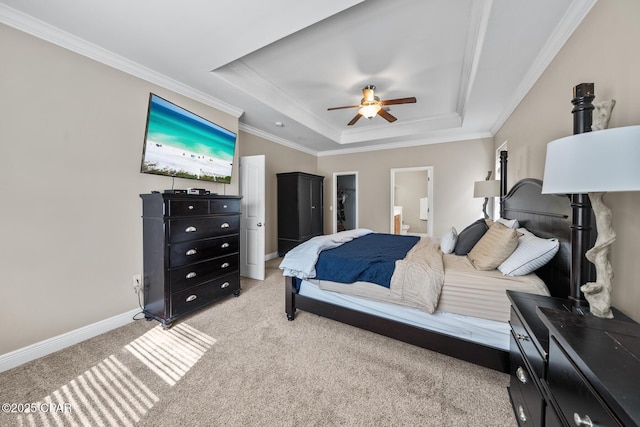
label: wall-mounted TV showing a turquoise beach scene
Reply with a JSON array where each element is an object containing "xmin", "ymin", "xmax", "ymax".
[{"xmin": 140, "ymin": 93, "xmax": 236, "ymax": 184}]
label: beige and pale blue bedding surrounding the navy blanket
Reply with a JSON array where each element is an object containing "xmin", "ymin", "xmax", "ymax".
[{"xmin": 280, "ymin": 229, "xmax": 549, "ymax": 322}]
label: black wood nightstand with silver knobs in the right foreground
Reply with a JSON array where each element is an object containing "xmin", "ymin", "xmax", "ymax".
[{"xmin": 507, "ymin": 291, "xmax": 640, "ymax": 427}]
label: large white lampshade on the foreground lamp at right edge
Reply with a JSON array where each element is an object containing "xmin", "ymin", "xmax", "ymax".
[{"xmin": 542, "ymin": 126, "xmax": 640, "ymax": 194}]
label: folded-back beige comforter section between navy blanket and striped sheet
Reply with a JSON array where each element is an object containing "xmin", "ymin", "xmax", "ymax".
[{"xmin": 390, "ymin": 238, "xmax": 444, "ymax": 313}]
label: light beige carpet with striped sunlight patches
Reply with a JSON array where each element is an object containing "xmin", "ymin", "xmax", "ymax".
[{"xmin": 0, "ymin": 259, "xmax": 516, "ymax": 427}]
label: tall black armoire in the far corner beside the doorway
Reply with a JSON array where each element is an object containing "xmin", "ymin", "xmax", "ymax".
[{"xmin": 277, "ymin": 172, "xmax": 324, "ymax": 256}]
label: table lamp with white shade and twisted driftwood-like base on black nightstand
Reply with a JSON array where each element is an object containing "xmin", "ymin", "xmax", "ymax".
[{"xmin": 542, "ymin": 126, "xmax": 640, "ymax": 318}]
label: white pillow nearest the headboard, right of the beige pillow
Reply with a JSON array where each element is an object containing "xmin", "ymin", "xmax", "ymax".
[{"xmin": 498, "ymin": 228, "xmax": 560, "ymax": 276}]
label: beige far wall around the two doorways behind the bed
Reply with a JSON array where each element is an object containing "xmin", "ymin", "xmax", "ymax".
[{"xmin": 318, "ymin": 138, "xmax": 495, "ymax": 241}]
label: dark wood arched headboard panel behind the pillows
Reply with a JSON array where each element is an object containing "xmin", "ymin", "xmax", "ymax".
[{"xmin": 501, "ymin": 179, "xmax": 571, "ymax": 298}]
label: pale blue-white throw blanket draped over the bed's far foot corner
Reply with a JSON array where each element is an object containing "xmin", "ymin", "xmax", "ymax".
[{"xmin": 280, "ymin": 228, "xmax": 373, "ymax": 279}]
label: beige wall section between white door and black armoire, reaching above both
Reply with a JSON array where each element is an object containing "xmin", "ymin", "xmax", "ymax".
[{"xmin": 239, "ymin": 132, "xmax": 316, "ymax": 254}]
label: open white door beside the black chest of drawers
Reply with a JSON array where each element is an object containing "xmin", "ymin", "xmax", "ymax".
[{"xmin": 240, "ymin": 155, "xmax": 265, "ymax": 280}]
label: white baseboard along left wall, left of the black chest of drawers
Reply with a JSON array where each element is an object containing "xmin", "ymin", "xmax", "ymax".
[{"xmin": 0, "ymin": 308, "xmax": 140, "ymax": 372}]
